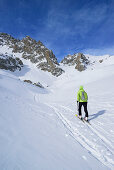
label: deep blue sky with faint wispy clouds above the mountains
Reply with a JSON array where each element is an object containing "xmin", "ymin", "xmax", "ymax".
[{"xmin": 0, "ymin": 0, "xmax": 114, "ymax": 60}]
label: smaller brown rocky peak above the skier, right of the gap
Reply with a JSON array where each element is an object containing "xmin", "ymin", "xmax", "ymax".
[{"xmin": 61, "ymin": 53, "xmax": 89, "ymax": 71}]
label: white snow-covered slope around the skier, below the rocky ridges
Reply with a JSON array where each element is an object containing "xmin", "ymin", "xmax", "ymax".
[{"xmin": 0, "ymin": 54, "xmax": 114, "ymax": 170}]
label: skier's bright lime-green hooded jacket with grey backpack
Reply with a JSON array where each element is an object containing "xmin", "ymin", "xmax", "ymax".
[{"xmin": 77, "ymin": 86, "xmax": 88, "ymax": 102}]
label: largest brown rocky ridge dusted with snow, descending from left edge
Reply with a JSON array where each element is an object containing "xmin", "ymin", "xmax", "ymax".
[{"xmin": 0, "ymin": 33, "xmax": 64, "ymax": 76}]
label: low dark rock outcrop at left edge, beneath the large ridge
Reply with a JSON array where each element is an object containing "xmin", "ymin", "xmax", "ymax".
[{"xmin": 0, "ymin": 54, "xmax": 23, "ymax": 71}]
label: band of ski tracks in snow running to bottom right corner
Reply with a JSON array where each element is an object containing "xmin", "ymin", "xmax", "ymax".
[{"xmin": 47, "ymin": 104, "xmax": 114, "ymax": 169}]
